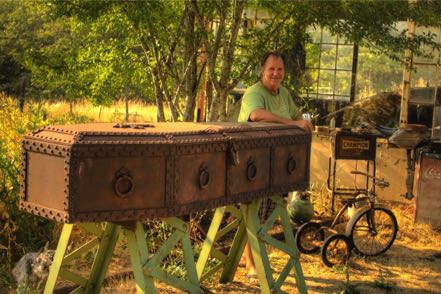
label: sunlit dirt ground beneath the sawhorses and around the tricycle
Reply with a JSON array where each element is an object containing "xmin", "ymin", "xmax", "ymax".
[{"xmin": 92, "ymin": 201, "xmax": 441, "ymax": 293}]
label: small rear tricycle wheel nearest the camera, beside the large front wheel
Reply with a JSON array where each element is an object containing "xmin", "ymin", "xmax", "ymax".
[{"xmin": 320, "ymin": 234, "xmax": 351, "ymax": 267}]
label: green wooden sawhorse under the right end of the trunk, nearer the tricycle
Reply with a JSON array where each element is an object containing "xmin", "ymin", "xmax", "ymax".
[{"xmin": 196, "ymin": 196, "xmax": 307, "ymax": 293}]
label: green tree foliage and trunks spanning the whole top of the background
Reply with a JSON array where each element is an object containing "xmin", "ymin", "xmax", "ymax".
[{"xmin": 0, "ymin": 0, "xmax": 441, "ymax": 120}]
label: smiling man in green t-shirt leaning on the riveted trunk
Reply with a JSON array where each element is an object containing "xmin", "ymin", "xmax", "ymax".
[{"xmin": 238, "ymin": 52, "xmax": 313, "ymax": 278}]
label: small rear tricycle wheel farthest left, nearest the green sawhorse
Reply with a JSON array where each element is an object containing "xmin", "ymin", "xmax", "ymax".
[{"xmin": 295, "ymin": 222, "xmax": 325, "ymax": 254}]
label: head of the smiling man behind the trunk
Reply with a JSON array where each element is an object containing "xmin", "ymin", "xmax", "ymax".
[{"xmin": 262, "ymin": 55, "xmax": 285, "ymax": 93}]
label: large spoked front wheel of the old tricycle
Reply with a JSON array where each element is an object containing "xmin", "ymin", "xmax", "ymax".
[{"xmin": 349, "ymin": 207, "xmax": 398, "ymax": 256}]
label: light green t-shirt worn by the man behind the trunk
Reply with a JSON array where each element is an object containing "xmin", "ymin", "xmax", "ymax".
[{"xmin": 238, "ymin": 82, "xmax": 300, "ymax": 122}]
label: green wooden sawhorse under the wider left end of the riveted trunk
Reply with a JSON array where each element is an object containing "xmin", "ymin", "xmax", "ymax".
[{"xmin": 44, "ymin": 217, "xmax": 203, "ymax": 294}]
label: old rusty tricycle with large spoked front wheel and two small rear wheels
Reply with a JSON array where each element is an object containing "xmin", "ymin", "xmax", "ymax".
[{"xmin": 295, "ymin": 171, "xmax": 398, "ymax": 267}]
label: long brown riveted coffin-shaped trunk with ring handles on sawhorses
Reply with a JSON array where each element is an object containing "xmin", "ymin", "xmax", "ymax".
[{"xmin": 20, "ymin": 123, "xmax": 311, "ymax": 223}]
